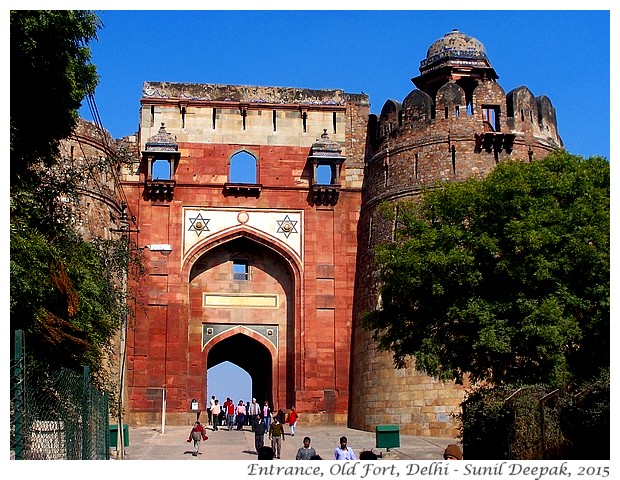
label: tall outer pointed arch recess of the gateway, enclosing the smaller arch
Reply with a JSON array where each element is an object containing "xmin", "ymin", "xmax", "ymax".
[{"xmin": 186, "ymin": 230, "xmax": 300, "ymax": 409}]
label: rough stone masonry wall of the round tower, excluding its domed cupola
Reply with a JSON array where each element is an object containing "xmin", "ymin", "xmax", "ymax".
[{"xmin": 349, "ymin": 77, "xmax": 561, "ymax": 437}]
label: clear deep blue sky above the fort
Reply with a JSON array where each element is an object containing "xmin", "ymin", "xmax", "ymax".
[{"xmin": 81, "ymin": 8, "xmax": 617, "ymax": 158}]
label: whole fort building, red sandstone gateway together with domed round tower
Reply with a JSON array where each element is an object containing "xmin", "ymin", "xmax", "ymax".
[{"xmin": 86, "ymin": 31, "xmax": 562, "ymax": 436}]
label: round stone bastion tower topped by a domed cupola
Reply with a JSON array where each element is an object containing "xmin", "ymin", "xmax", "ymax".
[{"xmin": 349, "ymin": 30, "xmax": 562, "ymax": 437}]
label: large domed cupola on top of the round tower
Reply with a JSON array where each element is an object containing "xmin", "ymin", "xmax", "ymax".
[{"xmin": 411, "ymin": 29, "xmax": 499, "ymax": 97}]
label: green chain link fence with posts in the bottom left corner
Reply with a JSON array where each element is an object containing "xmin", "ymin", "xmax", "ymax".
[{"xmin": 11, "ymin": 331, "xmax": 110, "ymax": 460}]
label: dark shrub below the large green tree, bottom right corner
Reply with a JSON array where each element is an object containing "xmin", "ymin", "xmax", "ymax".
[{"xmin": 459, "ymin": 373, "xmax": 610, "ymax": 460}]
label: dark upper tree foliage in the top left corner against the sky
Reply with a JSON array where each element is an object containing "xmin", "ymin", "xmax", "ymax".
[{"xmin": 10, "ymin": 10, "xmax": 101, "ymax": 187}]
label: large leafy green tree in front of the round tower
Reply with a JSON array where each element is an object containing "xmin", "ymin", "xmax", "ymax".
[{"xmin": 364, "ymin": 152, "xmax": 610, "ymax": 385}]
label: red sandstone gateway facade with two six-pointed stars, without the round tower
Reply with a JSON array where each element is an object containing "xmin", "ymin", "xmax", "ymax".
[{"xmin": 123, "ymin": 83, "xmax": 369, "ymax": 424}]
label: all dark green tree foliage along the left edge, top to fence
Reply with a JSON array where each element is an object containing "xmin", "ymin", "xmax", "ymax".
[{"xmin": 10, "ymin": 11, "xmax": 140, "ymax": 378}]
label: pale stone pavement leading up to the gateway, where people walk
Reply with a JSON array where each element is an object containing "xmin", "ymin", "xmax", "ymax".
[{"xmin": 110, "ymin": 425, "xmax": 458, "ymax": 461}]
